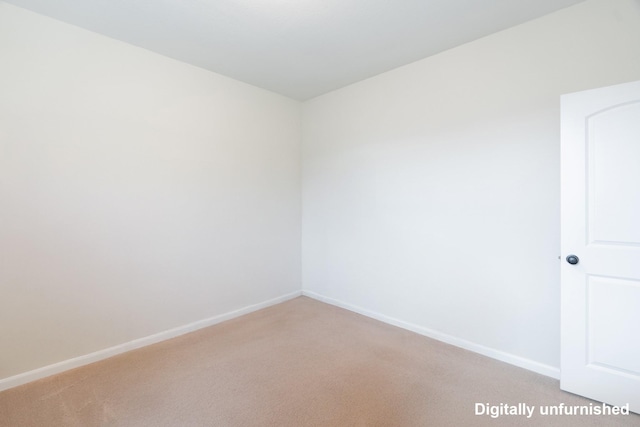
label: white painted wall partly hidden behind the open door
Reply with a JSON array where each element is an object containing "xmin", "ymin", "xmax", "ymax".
[{"xmin": 302, "ymin": 0, "xmax": 640, "ymax": 373}]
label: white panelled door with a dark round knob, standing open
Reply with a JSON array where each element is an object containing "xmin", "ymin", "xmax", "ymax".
[{"xmin": 560, "ymin": 82, "xmax": 640, "ymax": 413}]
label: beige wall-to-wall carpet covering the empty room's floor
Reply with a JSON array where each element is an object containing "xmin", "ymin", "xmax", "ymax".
[{"xmin": 0, "ymin": 297, "xmax": 640, "ymax": 427}]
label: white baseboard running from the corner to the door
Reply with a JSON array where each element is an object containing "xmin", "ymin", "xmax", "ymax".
[{"xmin": 302, "ymin": 290, "xmax": 560, "ymax": 379}]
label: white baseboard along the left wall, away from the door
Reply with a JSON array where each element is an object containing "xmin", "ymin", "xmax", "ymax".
[{"xmin": 0, "ymin": 291, "xmax": 302, "ymax": 391}]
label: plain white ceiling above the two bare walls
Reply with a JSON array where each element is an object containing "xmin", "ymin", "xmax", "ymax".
[{"xmin": 5, "ymin": 0, "xmax": 583, "ymax": 100}]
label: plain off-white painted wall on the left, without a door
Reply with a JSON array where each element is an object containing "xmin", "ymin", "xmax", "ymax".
[{"xmin": 0, "ymin": 3, "xmax": 300, "ymax": 379}]
